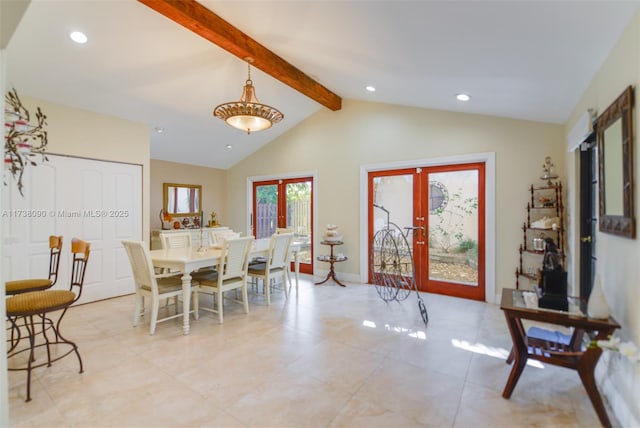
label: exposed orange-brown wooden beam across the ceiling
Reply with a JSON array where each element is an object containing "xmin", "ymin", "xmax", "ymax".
[{"xmin": 138, "ymin": 0, "xmax": 342, "ymax": 111}]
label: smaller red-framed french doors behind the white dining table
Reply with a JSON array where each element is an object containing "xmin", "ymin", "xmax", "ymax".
[{"xmin": 252, "ymin": 177, "xmax": 313, "ymax": 274}]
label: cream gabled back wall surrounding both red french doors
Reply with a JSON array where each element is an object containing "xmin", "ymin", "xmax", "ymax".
[{"xmin": 227, "ymin": 100, "xmax": 565, "ymax": 300}]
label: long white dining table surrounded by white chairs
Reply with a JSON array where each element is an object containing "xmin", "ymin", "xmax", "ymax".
[{"xmin": 149, "ymin": 238, "xmax": 302, "ymax": 335}]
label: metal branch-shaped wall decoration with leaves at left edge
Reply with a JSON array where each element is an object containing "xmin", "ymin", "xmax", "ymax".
[{"xmin": 4, "ymin": 88, "xmax": 49, "ymax": 196}]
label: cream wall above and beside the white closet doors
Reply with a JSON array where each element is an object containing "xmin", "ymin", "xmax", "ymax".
[{"xmin": 18, "ymin": 93, "xmax": 149, "ymax": 240}]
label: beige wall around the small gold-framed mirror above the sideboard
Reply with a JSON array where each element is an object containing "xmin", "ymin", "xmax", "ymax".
[{"xmin": 150, "ymin": 160, "xmax": 227, "ymax": 229}]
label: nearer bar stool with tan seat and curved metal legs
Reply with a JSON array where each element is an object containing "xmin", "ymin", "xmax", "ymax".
[{"xmin": 5, "ymin": 238, "xmax": 91, "ymax": 401}]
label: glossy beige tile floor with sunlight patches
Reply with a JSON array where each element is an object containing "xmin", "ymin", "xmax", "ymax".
[{"xmin": 9, "ymin": 275, "xmax": 615, "ymax": 428}]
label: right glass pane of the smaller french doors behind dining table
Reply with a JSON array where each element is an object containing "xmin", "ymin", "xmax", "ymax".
[{"xmin": 285, "ymin": 180, "xmax": 311, "ymax": 263}]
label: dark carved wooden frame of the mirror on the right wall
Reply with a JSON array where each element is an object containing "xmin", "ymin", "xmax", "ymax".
[{"xmin": 597, "ymin": 86, "xmax": 636, "ymax": 238}]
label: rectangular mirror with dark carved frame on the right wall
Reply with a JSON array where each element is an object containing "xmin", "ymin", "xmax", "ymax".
[{"xmin": 597, "ymin": 86, "xmax": 635, "ymax": 238}]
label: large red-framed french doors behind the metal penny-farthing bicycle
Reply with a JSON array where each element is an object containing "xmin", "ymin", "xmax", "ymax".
[{"xmin": 368, "ymin": 163, "xmax": 485, "ymax": 300}]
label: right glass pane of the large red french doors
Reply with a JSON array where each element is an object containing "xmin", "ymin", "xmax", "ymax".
[{"xmin": 428, "ymin": 170, "xmax": 478, "ymax": 286}]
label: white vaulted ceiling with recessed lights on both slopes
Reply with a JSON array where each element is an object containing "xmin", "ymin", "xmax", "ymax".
[{"xmin": 3, "ymin": 0, "xmax": 640, "ymax": 169}]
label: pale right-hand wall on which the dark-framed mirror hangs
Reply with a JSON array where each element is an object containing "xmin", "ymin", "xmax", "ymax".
[{"xmin": 566, "ymin": 13, "xmax": 640, "ymax": 426}]
